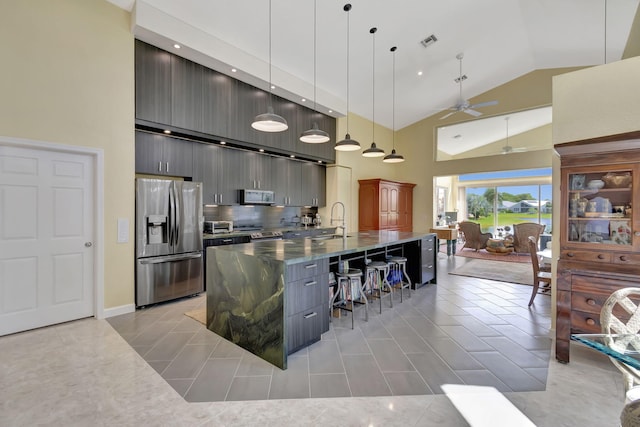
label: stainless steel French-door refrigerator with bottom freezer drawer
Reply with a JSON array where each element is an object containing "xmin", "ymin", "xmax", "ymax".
[{"xmin": 136, "ymin": 178, "xmax": 204, "ymax": 307}]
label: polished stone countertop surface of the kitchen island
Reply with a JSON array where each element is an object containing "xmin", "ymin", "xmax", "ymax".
[{"xmin": 208, "ymin": 230, "xmax": 430, "ymax": 264}]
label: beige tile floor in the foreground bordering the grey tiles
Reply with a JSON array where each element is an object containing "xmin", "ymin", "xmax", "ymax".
[{"xmin": 0, "ymin": 252, "xmax": 623, "ymax": 427}]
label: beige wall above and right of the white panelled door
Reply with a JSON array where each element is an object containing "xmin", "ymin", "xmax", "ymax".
[{"xmin": 0, "ymin": 0, "xmax": 135, "ymax": 308}]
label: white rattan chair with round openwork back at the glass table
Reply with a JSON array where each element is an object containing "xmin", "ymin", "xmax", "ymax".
[{"xmin": 600, "ymin": 287, "xmax": 640, "ymax": 401}]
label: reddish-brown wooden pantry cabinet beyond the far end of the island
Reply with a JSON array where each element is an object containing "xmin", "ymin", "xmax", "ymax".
[{"xmin": 358, "ymin": 178, "xmax": 416, "ymax": 231}]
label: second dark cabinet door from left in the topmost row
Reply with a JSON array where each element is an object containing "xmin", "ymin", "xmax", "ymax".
[{"xmin": 171, "ymin": 56, "xmax": 205, "ymax": 132}]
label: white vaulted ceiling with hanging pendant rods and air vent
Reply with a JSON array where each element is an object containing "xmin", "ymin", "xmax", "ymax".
[{"xmin": 109, "ymin": 0, "xmax": 640, "ymax": 132}]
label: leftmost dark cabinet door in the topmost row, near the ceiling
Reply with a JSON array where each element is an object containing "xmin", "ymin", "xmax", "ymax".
[{"xmin": 135, "ymin": 40, "xmax": 172, "ymax": 124}]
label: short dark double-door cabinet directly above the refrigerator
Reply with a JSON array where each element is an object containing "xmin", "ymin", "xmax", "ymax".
[{"xmin": 136, "ymin": 131, "xmax": 193, "ymax": 177}]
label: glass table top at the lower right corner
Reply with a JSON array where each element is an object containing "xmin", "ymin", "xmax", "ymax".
[{"xmin": 571, "ymin": 334, "xmax": 640, "ymax": 369}]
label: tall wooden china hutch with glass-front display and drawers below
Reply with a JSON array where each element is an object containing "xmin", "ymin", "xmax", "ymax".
[{"xmin": 555, "ymin": 132, "xmax": 640, "ymax": 363}]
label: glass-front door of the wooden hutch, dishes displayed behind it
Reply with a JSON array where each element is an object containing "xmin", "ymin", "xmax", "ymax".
[{"xmin": 563, "ymin": 164, "xmax": 640, "ymax": 251}]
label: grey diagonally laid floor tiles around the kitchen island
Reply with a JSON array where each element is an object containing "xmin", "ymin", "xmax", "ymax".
[{"xmin": 109, "ymin": 257, "xmax": 552, "ymax": 402}]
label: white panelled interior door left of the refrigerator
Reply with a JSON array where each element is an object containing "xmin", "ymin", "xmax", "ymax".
[{"xmin": 0, "ymin": 145, "xmax": 95, "ymax": 336}]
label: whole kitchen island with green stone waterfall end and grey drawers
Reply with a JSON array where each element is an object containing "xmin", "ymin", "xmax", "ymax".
[{"xmin": 206, "ymin": 231, "xmax": 437, "ymax": 369}]
